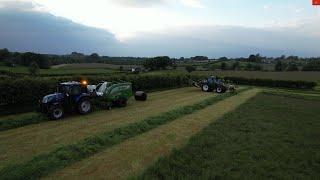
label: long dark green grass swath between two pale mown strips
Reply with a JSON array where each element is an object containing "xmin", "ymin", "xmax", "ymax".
[{"xmin": 0, "ymin": 88, "xmax": 248, "ymax": 179}]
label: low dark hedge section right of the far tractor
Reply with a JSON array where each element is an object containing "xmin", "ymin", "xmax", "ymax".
[{"xmin": 224, "ymin": 77, "xmax": 317, "ymax": 89}]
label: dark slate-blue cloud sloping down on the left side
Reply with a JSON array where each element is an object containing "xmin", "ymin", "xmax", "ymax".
[{"xmin": 0, "ymin": 6, "xmax": 119, "ymax": 54}]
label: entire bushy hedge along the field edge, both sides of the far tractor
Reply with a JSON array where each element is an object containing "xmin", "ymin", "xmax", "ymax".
[{"xmin": 0, "ymin": 74, "xmax": 316, "ymax": 105}]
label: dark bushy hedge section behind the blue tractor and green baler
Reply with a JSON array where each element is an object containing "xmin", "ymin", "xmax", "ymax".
[{"xmin": 0, "ymin": 75, "xmax": 188, "ymax": 105}]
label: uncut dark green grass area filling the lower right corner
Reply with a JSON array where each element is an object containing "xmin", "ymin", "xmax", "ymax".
[{"xmin": 137, "ymin": 94, "xmax": 320, "ymax": 179}]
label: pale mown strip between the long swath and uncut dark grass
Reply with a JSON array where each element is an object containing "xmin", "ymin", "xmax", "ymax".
[{"xmin": 46, "ymin": 89, "xmax": 260, "ymax": 179}]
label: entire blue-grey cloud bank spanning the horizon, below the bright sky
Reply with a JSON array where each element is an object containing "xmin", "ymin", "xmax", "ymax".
[{"xmin": 0, "ymin": 1, "xmax": 320, "ymax": 57}]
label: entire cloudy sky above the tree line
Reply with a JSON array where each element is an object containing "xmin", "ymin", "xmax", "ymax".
[{"xmin": 0, "ymin": 0, "xmax": 320, "ymax": 57}]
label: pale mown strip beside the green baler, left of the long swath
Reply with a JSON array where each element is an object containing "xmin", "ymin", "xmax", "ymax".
[{"xmin": 0, "ymin": 88, "xmax": 215, "ymax": 169}]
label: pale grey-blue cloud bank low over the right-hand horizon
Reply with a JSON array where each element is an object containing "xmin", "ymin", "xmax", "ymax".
[{"xmin": 122, "ymin": 22, "xmax": 320, "ymax": 57}]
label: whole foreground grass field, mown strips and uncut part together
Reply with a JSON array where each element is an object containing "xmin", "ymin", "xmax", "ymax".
[{"xmin": 0, "ymin": 87, "xmax": 320, "ymax": 179}]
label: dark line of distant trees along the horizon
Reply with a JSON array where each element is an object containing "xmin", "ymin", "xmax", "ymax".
[{"xmin": 0, "ymin": 49, "xmax": 320, "ymax": 74}]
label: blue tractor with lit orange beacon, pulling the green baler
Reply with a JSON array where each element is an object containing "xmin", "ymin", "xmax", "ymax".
[{"xmin": 40, "ymin": 81, "xmax": 93, "ymax": 120}]
